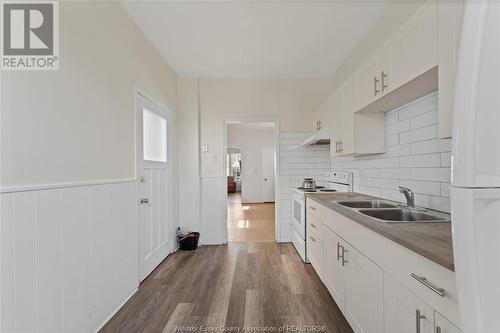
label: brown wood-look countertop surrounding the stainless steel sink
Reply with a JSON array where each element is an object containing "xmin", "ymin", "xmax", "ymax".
[{"xmin": 306, "ymin": 192, "xmax": 455, "ymax": 271}]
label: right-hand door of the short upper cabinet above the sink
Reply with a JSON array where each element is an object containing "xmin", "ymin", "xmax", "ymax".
[{"xmin": 383, "ymin": 0, "xmax": 438, "ymax": 93}]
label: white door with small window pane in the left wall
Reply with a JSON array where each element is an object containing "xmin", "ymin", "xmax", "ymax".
[{"xmin": 136, "ymin": 94, "xmax": 171, "ymax": 281}]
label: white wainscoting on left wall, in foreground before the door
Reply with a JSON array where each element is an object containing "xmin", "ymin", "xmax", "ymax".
[{"xmin": 0, "ymin": 182, "xmax": 139, "ymax": 332}]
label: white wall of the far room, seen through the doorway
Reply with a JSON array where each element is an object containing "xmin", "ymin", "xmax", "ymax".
[{"xmin": 227, "ymin": 123, "xmax": 275, "ymax": 203}]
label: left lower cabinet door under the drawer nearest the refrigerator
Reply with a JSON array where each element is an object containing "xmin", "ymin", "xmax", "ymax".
[{"xmin": 384, "ymin": 274, "xmax": 434, "ymax": 333}]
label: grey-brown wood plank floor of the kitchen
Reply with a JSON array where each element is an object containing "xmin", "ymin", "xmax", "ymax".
[{"xmin": 101, "ymin": 242, "xmax": 352, "ymax": 333}]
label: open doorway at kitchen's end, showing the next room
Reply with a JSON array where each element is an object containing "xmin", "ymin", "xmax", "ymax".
[{"xmin": 225, "ymin": 121, "xmax": 278, "ymax": 242}]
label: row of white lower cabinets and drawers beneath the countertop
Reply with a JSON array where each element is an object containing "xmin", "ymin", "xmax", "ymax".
[{"xmin": 307, "ymin": 200, "xmax": 461, "ymax": 333}]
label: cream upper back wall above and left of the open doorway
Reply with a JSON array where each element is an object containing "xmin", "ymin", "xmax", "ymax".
[{"xmin": 200, "ymin": 78, "xmax": 329, "ymax": 176}]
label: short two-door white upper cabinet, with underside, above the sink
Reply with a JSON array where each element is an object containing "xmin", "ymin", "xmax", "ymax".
[{"xmin": 353, "ymin": 0, "xmax": 438, "ymax": 112}]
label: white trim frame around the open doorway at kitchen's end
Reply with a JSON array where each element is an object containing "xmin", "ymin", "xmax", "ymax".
[{"xmin": 221, "ymin": 116, "xmax": 281, "ymax": 243}]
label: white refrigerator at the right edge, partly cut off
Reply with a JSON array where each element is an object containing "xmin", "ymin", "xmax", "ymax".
[{"xmin": 451, "ymin": 0, "xmax": 500, "ymax": 333}]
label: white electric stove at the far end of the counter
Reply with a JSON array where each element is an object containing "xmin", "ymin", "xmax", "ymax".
[{"xmin": 292, "ymin": 171, "xmax": 353, "ymax": 262}]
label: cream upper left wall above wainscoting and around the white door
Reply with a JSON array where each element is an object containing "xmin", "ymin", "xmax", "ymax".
[{"xmin": 0, "ymin": 1, "xmax": 177, "ymax": 188}]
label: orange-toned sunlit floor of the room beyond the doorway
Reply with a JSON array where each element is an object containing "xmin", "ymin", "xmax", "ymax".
[{"xmin": 227, "ymin": 193, "xmax": 275, "ymax": 242}]
